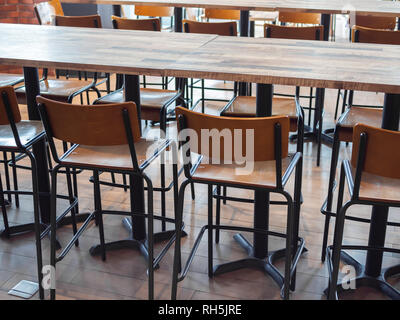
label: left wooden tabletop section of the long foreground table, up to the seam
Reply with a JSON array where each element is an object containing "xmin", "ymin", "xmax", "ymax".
[{"xmin": 0, "ymin": 23, "xmax": 216, "ymax": 76}]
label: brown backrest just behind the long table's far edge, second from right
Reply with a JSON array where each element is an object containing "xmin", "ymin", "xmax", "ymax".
[{"xmin": 264, "ymin": 23, "xmax": 324, "ymax": 40}]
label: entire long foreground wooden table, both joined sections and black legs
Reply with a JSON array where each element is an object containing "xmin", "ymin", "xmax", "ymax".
[{"xmin": 0, "ymin": 24, "xmax": 400, "ymax": 297}]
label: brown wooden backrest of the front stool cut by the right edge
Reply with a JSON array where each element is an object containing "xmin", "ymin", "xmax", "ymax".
[{"xmin": 351, "ymin": 124, "xmax": 400, "ymax": 179}]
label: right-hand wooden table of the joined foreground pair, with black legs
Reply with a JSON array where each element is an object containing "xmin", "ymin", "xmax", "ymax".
[{"xmin": 166, "ymin": 37, "xmax": 400, "ymax": 299}]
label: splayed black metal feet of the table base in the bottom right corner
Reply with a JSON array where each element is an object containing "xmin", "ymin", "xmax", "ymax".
[{"xmin": 325, "ymin": 251, "xmax": 400, "ymax": 300}]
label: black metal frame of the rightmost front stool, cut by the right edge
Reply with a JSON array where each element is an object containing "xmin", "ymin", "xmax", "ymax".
[{"xmin": 326, "ymin": 132, "xmax": 400, "ymax": 300}]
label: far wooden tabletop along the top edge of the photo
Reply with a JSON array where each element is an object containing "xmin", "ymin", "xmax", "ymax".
[{"xmin": 61, "ymin": 0, "xmax": 400, "ymax": 16}]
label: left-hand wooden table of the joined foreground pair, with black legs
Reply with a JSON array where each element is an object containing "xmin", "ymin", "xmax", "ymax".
[{"xmin": 0, "ymin": 24, "xmax": 216, "ymax": 260}]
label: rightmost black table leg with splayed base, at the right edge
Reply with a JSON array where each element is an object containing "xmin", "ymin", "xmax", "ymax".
[{"xmin": 330, "ymin": 94, "xmax": 400, "ymax": 300}]
